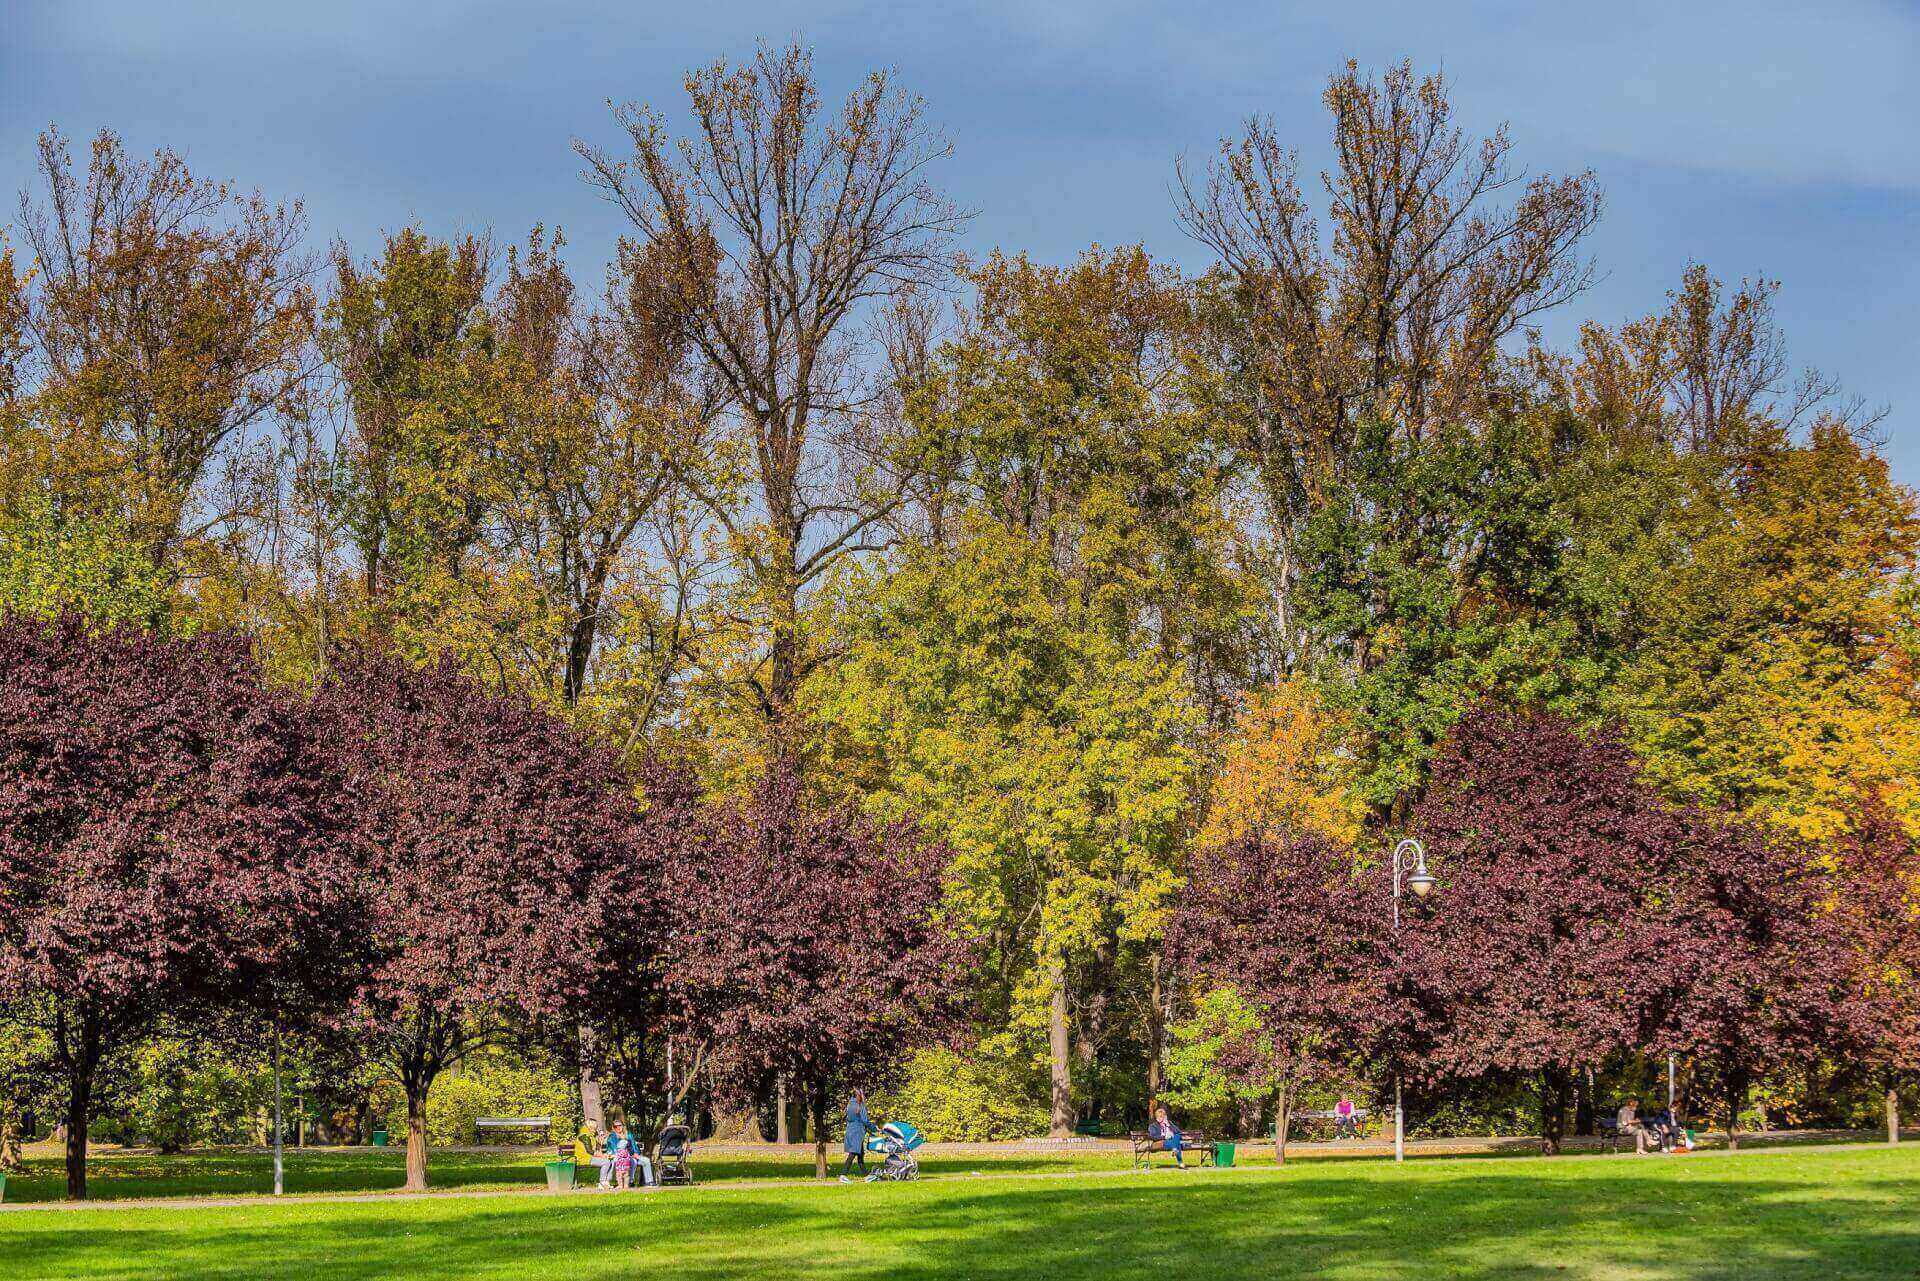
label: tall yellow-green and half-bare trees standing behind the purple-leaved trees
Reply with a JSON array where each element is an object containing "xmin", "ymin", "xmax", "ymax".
[{"xmin": 0, "ymin": 48, "xmax": 1920, "ymax": 1133}]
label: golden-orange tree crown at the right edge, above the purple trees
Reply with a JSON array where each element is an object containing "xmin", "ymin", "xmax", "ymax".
[{"xmin": 1615, "ymin": 421, "xmax": 1920, "ymax": 839}]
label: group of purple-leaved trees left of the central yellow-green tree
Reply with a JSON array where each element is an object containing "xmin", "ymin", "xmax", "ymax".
[{"xmin": 0, "ymin": 616, "xmax": 966, "ymax": 1198}]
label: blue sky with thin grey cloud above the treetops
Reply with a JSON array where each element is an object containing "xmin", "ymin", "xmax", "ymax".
[{"xmin": 11, "ymin": 0, "xmax": 1920, "ymax": 482}]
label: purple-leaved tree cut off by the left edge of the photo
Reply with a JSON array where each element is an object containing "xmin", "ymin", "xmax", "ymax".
[{"xmin": 0, "ymin": 616, "xmax": 353, "ymax": 1200}]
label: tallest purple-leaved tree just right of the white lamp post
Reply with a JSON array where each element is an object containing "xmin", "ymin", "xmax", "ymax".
[{"xmin": 1394, "ymin": 707, "xmax": 1693, "ymax": 1152}]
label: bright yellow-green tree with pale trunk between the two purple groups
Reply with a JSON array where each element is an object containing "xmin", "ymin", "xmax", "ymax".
[{"xmin": 824, "ymin": 526, "xmax": 1196, "ymax": 1131}]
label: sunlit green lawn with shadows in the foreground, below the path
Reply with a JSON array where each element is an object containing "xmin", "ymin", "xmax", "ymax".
[{"xmin": 0, "ymin": 1147, "xmax": 1920, "ymax": 1281}]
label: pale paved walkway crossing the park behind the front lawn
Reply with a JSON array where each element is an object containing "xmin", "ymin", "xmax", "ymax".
[{"xmin": 0, "ymin": 1129, "xmax": 1916, "ymax": 1214}]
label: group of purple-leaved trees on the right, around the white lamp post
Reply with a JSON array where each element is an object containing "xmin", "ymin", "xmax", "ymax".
[{"xmin": 1171, "ymin": 707, "xmax": 1920, "ymax": 1160}]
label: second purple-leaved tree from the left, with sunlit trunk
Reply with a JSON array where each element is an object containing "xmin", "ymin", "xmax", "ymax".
[{"xmin": 315, "ymin": 659, "xmax": 637, "ymax": 1189}]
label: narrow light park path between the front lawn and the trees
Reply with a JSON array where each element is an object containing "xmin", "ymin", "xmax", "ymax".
[{"xmin": 0, "ymin": 1131, "xmax": 1887, "ymax": 1216}]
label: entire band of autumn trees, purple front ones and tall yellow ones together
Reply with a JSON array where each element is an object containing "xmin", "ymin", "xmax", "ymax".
[{"xmin": 0, "ymin": 44, "xmax": 1920, "ymax": 1195}]
